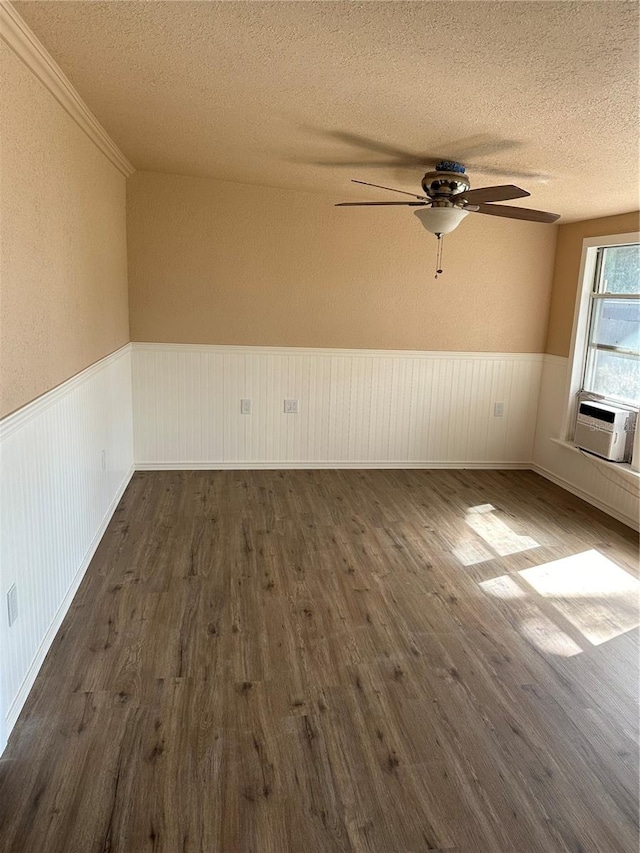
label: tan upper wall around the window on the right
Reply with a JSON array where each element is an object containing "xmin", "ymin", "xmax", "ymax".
[{"xmin": 546, "ymin": 211, "xmax": 640, "ymax": 356}]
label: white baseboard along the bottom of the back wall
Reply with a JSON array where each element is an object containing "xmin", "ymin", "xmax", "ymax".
[{"xmin": 136, "ymin": 460, "xmax": 531, "ymax": 471}]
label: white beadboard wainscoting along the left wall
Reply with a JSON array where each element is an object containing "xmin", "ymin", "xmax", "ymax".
[{"xmin": 0, "ymin": 345, "xmax": 133, "ymax": 752}]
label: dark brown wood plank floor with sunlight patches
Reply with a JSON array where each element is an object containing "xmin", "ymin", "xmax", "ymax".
[{"xmin": 0, "ymin": 471, "xmax": 638, "ymax": 853}]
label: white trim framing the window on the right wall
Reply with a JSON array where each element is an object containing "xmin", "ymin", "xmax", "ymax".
[{"xmin": 560, "ymin": 231, "xmax": 640, "ymax": 471}]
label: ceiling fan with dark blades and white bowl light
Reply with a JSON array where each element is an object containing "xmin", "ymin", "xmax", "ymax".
[{"xmin": 336, "ymin": 160, "xmax": 560, "ymax": 239}]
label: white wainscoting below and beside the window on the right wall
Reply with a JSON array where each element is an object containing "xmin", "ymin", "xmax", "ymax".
[{"xmin": 531, "ymin": 355, "xmax": 640, "ymax": 530}]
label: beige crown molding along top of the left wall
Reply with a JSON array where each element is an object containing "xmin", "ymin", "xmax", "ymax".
[{"xmin": 0, "ymin": 0, "xmax": 135, "ymax": 177}]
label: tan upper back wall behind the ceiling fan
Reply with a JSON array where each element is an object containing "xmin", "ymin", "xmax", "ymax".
[{"xmin": 127, "ymin": 172, "xmax": 557, "ymax": 352}]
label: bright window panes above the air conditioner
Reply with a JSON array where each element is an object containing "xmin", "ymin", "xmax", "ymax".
[{"xmin": 582, "ymin": 243, "xmax": 640, "ymax": 406}]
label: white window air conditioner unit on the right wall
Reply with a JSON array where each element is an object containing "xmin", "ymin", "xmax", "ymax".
[{"xmin": 573, "ymin": 400, "xmax": 636, "ymax": 462}]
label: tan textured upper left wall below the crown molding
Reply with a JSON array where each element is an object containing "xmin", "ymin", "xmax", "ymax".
[{"xmin": 0, "ymin": 42, "xmax": 129, "ymax": 415}]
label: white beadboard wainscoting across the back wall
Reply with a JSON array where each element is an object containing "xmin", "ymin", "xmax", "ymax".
[{"xmin": 132, "ymin": 344, "xmax": 542, "ymax": 469}]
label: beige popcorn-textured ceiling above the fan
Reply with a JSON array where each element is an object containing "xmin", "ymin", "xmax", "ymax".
[{"xmin": 14, "ymin": 0, "xmax": 639, "ymax": 221}]
